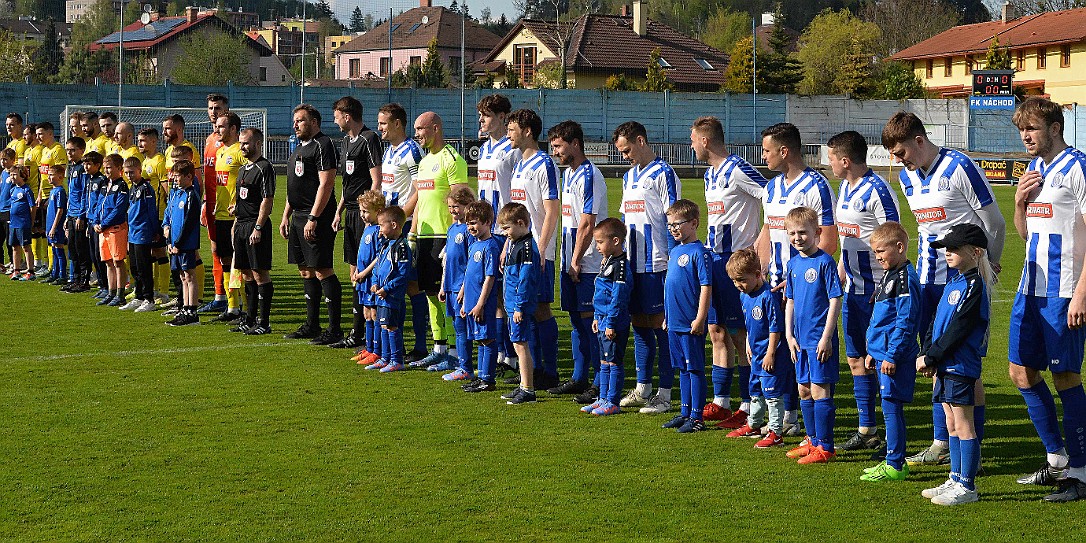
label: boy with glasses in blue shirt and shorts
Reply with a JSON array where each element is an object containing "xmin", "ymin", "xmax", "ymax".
[{"xmin": 664, "ymin": 200, "xmax": 712, "ymax": 433}]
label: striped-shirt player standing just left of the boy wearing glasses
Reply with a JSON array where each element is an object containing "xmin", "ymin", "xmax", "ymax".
[{"xmin": 611, "ymin": 121, "xmax": 682, "ymax": 414}]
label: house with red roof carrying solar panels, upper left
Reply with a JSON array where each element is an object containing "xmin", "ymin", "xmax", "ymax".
[{"xmin": 88, "ymin": 8, "xmax": 293, "ymax": 86}]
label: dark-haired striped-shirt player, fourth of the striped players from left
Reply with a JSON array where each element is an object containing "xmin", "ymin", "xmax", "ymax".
[{"xmin": 547, "ymin": 121, "xmax": 607, "ymax": 396}]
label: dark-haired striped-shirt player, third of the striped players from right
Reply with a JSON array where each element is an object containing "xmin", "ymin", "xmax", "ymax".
[{"xmin": 826, "ymin": 130, "xmax": 900, "ymax": 451}]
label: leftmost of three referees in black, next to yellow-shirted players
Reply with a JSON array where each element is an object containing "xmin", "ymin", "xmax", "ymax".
[{"xmin": 231, "ymin": 128, "xmax": 275, "ymax": 336}]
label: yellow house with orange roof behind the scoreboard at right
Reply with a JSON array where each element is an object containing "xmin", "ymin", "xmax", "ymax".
[{"xmin": 891, "ymin": 5, "xmax": 1086, "ymax": 104}]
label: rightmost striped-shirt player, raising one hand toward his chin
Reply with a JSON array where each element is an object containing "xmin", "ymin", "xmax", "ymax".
[{"xmin": 1008, "ymin": 98, "xmax": 1086, "ymax": 502}]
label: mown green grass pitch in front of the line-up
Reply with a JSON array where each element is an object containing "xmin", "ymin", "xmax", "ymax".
[{"xmin": 0, "ymin": 172, "xmax": 1086, "ymax": 542}]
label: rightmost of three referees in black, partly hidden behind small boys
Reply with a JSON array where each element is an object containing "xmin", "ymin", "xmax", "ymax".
[{"xmin": 330, "ymin": 97, "xmax": 383, "ymax": 349}]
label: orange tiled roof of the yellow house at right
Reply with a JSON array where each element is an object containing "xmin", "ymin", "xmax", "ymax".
[{"xmin": 891, "ymin": 8, "xmax": 1086, "ymax": 60}]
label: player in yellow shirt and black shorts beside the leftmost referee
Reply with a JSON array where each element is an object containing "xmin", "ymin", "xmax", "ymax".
[{"xmin": 211, "ymin": 112, "xmax": 249, "ymax": 323}]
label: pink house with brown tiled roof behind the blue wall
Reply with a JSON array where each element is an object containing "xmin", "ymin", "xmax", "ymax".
[{"xmin": 332, "ymin": 0, "xmax": 502, "ymax": 79}]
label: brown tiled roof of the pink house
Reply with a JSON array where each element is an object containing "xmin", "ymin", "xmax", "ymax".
[{"xmin": 336, "ymin": 7, "xmax": 502, "ymax": 53}]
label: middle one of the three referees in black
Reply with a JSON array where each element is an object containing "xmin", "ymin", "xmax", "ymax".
[{"xmin": 279, "ymin": 104, "xmax": 343, "ymax": 345}]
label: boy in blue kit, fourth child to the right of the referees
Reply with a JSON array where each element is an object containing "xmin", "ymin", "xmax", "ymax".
[{"xmin": 462, "ymin": 200, "xmax": 504, "ymax": 392}]
